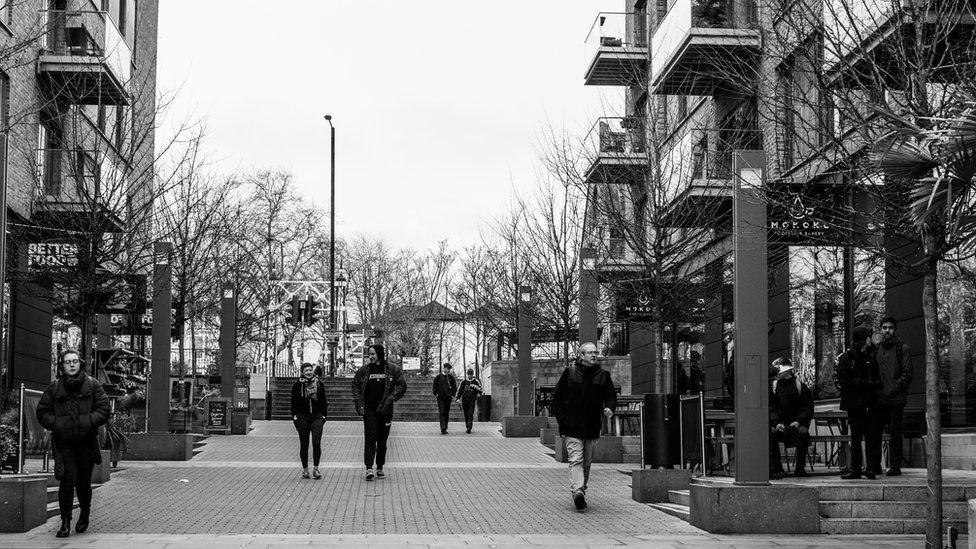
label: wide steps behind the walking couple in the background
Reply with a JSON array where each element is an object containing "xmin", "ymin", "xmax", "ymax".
[{"xmin": 271, "ymin": 375, "xmax": 440, "ymax": 421}]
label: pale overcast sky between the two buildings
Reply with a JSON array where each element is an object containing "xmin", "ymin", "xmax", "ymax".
[{"xmin": 158, "ymin": 0, "xmax": 623, "ymax": 249}]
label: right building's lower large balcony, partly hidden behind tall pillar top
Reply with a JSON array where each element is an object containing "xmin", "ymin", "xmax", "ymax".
[{"xmin": 661, "ymin": 128, "xmax": 762, "ymax": 228}]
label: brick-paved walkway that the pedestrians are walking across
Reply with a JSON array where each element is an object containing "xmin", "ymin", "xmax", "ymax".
[{"xmin": 0, "ymin": 421, "xmax": 944, "ymax": 548}]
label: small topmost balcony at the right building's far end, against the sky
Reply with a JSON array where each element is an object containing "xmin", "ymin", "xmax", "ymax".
[{"xmin": 583, "ymin": 12, "xmax": 647, "ymax": 86}]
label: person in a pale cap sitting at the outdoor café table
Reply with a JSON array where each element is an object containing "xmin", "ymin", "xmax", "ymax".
[{"xmin": 769, "ymin": 358, "xmax": 813, "ymax": 479}]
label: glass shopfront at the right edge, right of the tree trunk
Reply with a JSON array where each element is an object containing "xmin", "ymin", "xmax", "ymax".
[{"xmin": 938, "ymin": 258, "xmax": 976, "ymax": 427}]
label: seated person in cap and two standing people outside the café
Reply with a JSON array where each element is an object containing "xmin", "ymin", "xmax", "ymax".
[{"xmin": 769, "ymin": 316, "xmax": 912, "ymax": 480}]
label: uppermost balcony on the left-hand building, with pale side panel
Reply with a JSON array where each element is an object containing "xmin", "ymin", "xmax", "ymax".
[{"xmin": 37, "ymin": 10, "xmax": 132, "ymax": 105}]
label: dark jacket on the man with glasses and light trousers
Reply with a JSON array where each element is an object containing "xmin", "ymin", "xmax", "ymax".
[{"xmin": 552, "ymin": 360, "xmax": 617, "ymax": 439}]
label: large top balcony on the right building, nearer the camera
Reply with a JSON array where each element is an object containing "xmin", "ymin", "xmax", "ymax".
[{"xmin": 651, "ymin": 0, "xmax": 760, "ymax": 95}]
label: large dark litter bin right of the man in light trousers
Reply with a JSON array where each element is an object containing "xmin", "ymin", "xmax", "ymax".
[{"xmin": 641, "ymin": 393, "xmax": 681, "ymax": 468}]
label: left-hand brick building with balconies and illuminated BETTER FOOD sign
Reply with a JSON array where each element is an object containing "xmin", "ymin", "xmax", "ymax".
[{"xmin": 0, "ymin": 0, "xmax": 158, "ymax": 391}]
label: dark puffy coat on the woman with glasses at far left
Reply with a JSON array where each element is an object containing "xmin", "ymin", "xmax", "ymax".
[{"xmin": 36, "ymin": 373, "xmax": 112, "ymax": 463}]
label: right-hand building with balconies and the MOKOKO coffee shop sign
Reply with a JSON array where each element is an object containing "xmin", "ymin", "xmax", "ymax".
[{"xmin": 579, "ymin": 0, "xmax": 976, "ymax": 438}]
